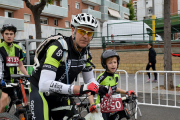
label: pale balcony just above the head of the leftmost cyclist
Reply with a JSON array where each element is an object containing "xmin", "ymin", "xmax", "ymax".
[{"xmin": 0, "ymin": 16, "xmax": 24, "ymax": 30}]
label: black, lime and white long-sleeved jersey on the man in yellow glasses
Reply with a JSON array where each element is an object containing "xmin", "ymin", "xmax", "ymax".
[{"xmin": 30, "ymin": 36, "xmax": 98, "ymax": 94}]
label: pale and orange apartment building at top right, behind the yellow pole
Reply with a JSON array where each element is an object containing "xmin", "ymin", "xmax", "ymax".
[{"xmin": 136, "ymin": 0, "xmax": 180, "ymax": 20}]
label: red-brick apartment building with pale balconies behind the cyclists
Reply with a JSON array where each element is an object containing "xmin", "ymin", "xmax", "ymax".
[{"xmin": 0, "ymin": 0, "xmax": 129, "ymax": 39}]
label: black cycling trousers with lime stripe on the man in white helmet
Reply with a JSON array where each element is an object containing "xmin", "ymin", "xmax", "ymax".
[{"xmin": 30, "ymin": 84, "xmax": 68, "ymax": 120}]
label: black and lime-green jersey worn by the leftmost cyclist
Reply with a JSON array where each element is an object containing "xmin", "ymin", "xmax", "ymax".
[{"xmin": 0, "ymin": 42, "xmax": 23, "ymax": 82}]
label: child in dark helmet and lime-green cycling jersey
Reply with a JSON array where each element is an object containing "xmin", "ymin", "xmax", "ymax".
[{"xmin": 96, "ymin": 50, "xmax": 134, "ymax": 120}]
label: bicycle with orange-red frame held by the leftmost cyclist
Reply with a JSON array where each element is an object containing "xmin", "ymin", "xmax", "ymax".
[{"xmin": 0, "ymin": 74, "xmax": 32, "ymax": 120}]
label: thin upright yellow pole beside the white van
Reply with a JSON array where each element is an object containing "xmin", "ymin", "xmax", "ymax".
[{"xmin": 152, "ymin": 0, "xmax": 156, "ymax": 41}]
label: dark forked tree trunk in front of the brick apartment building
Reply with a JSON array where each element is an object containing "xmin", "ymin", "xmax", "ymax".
[{"xmin": 23, "ymin": 0, "xmax": 53, "ymax": 42}]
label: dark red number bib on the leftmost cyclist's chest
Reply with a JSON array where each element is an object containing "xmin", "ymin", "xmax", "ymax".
[{"xmin": 6, "ymin": 57, "xmax": 19, "ymax": 67}]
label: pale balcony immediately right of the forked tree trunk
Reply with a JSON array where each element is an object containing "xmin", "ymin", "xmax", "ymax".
[{"xmin": 35, "ymin": 2, "xmax": 68, "ymax": 18}]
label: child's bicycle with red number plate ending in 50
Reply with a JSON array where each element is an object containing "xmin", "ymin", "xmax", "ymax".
[{"xmin": 83, "ymin": 93, "xmax": 137, "ymax": 120}]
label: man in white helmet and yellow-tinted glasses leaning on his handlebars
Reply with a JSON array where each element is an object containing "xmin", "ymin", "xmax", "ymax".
[{"xmin": 30, "ymin": 13, "xmax": 108, "ymax": 120}]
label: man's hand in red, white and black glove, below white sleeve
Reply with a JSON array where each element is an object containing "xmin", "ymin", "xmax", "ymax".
[{"xmin": 80, "ymin": 82, "xmax": 99, "ymax": 95}]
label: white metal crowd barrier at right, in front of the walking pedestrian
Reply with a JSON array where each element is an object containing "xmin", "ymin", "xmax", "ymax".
[{"xmin": 135, "ymin": 71, "xmax": 180, "ymax": 118}]
